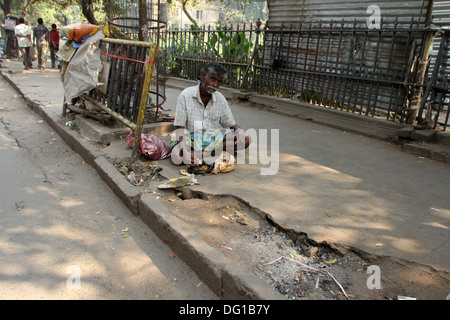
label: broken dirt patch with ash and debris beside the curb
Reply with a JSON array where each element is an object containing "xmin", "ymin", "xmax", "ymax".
[{"xmin": 113, "ymin": 160, "xmax": 450, "ymax": 300}]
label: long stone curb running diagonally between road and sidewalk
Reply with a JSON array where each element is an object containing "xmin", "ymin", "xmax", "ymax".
[{"xmin": 2, "ymin": 73, "xmax": 286, "ymax": 300}]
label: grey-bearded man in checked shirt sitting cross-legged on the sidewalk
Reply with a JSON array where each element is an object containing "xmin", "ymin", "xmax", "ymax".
[{"xmin": 170, "ymin": 62, "xmax": 251, "ymax": 166}]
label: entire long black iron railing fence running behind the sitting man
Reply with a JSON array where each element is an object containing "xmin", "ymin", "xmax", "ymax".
[{"xmin": 156, "ymin": 20, "xmax": 449, "ymax": 130}]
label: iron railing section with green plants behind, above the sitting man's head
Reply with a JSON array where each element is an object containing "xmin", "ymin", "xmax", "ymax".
[{"xmin": 160, "ymin": 23, "xmax": 263, "ymax": 88}]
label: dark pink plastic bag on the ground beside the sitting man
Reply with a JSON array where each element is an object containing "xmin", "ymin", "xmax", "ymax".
[{"xmin": 125, "ymin": 131, "xmax": 170, "ymax": 160}]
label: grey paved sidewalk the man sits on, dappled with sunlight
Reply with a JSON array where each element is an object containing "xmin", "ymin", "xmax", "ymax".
[{"xmin": 0, "ymin": 61, "xmax": 450, "ymax": 271}]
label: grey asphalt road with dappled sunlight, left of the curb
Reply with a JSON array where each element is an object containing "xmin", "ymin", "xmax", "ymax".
[{"xmin": 0, "ymin": 77, "xmax": 217, "ymax": 300}]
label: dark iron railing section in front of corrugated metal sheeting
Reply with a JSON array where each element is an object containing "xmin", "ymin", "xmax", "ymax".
[{"xmin": 258, "ymin": 21, "xmax": 424, "ymax": 121}]
